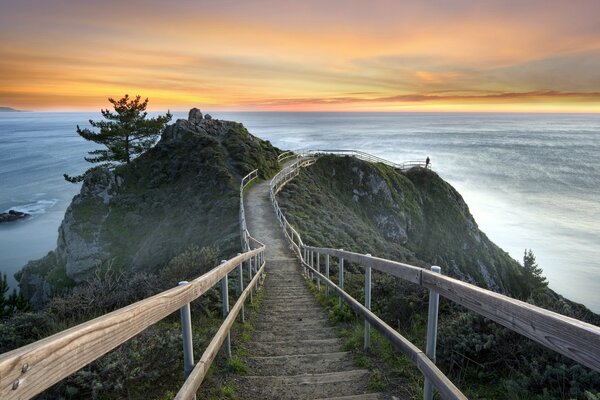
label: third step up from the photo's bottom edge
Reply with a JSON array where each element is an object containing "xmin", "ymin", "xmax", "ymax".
[{"xmin": 248, "ymin": 338, "xmax": 342, "ymax": 357}]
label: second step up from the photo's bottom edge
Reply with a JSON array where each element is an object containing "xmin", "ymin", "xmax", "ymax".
[{"xmin": 246, "ymin": 351, "xmax": 356, "ymax": 376}]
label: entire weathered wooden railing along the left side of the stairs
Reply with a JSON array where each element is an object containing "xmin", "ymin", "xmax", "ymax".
[{"xmin": 0, "ymin": 170, "xmax": 266, "ymax": 400}]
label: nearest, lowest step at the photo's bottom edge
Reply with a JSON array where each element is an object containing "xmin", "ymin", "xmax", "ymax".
[{"xmin": 240, "ymin": 370, "xmax": 369, "ymax": 400}]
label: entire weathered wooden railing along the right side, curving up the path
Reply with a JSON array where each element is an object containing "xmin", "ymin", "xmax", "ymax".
[{"xmin": 270, "ymin": 152, "xmax": 600, "ymax": 399}]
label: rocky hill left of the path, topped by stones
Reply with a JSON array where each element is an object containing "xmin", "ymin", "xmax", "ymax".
[{"xmin": 17, "ymin": 109, "xmax": 280, "ymax": 304}]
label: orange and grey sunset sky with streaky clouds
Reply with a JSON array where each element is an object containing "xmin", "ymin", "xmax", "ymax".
[{"xmin": 0, "ymin": 0, "xmax": 600, "ymax": 112}]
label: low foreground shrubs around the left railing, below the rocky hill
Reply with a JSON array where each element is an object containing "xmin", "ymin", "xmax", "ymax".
[{"xmin": 0, "ymin": 246, "xmax": 260, "ymax": 399}]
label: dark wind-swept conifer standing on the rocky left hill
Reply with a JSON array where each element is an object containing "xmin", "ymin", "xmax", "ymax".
[{"xmin": 64, "ymin": 94, "xmax": 172, "ymax": 182}]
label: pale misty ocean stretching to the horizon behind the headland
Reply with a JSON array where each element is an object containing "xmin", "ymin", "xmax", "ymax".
[{"xmin": 0, "ymin": 112, "xmax": 600, "ymax": 312}]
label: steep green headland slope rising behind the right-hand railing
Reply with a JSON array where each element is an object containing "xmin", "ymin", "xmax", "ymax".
[{"xmin": 280, "ymin": 156, "xmax": 520, "ymax": 293}]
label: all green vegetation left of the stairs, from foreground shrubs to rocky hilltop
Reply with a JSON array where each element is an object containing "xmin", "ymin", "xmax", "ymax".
[{"xmin": 0, "ymin": 111, "xmax": 280, "ymax": 399}]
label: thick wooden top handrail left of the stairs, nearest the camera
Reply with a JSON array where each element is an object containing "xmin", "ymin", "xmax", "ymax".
[{"xmin": 0, "ymin": 246, "xmax": 264, "ymax": 399}]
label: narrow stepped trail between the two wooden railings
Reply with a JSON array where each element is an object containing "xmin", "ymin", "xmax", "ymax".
[{"xmin": 236, "ymin": 173, "xmax": 384, "ymax": 400}]
